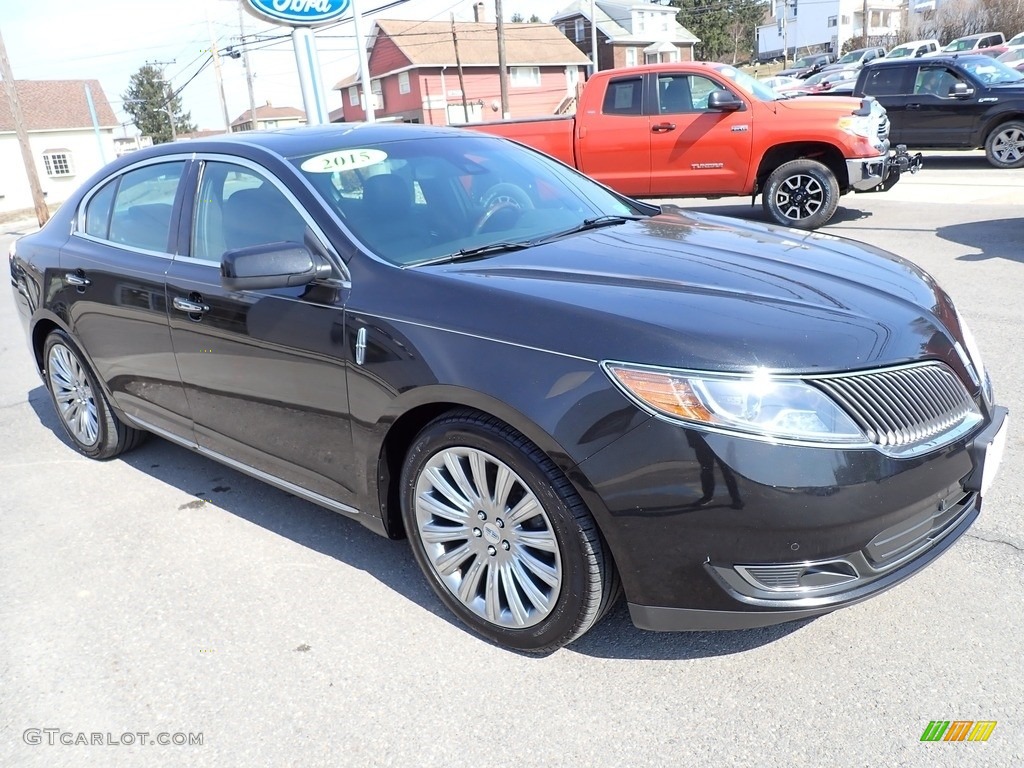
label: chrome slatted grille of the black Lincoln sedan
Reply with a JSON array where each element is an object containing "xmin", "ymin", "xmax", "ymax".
[{"xmin": 813, "ymin": 362, "xmax": 981, "ymax": 449}]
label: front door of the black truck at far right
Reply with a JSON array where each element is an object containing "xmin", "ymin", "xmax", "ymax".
[{"xmin": 901, "ymin": 63, "xmax": 985, "ymax": 147}]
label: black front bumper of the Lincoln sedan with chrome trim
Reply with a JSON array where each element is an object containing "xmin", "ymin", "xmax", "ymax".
[{"xmin": 581, "ymin": 408, "xmax": 1008, "ymax": 631}]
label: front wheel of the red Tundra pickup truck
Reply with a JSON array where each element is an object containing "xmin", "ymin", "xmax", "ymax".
[{"xmin": 762, "ymin": 158, "xmax": 839, "ymax": 229}]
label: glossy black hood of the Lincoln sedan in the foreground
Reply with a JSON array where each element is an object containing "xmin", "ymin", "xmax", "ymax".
[{"xmin": 415, "ymin": 211, "xmax": 959, "ymax": 373}]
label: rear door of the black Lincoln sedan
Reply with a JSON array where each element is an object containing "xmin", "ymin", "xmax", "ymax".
[{"xmin": 54, "ymin": 156, "xmax": 191, "ymax": 437}]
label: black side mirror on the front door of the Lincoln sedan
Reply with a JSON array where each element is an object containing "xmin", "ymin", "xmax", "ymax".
[{"xmin": 220, "ymin": 243, "xmax": 332, "ymax": 291}]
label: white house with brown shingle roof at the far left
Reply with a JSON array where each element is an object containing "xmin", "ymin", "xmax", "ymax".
[{"xmin": 0, "ymin": 80, "xmax": 118, "ymax": 213}]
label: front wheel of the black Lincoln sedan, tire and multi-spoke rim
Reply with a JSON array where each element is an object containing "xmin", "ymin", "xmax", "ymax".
[{"xmin": 401, "ymin": 410, "xmax": 621, "ymax": 653}]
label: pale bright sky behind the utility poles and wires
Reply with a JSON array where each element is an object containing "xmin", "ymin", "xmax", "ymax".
[{"xmin": 0, "ymin": 0, "xmax": 569, "ymax": 135}]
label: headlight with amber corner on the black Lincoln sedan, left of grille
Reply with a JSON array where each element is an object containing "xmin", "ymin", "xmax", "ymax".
[{"xmin": 602, "ymin": 361, "xmax": 866, "ymax": 444}]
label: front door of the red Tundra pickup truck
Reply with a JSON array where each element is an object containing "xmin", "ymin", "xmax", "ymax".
[{"xmin": 648, "ymin": 73, "xmax": 754, "ymax": 197}]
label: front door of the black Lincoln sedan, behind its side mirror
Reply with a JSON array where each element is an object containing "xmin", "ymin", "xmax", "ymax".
[{"xmin": 167, "ymin": 156, "xmax": 355, "ymax": 512}]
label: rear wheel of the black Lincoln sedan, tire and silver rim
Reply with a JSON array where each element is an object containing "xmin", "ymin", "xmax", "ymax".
[{"xmin": 43, "ymin": 330, "xmax": 146, "ymax": 460}]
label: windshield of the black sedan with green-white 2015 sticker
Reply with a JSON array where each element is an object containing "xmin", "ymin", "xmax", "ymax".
[{"xmin": 290, "ymin": 137, "xmax": 643, "ymax": 266}]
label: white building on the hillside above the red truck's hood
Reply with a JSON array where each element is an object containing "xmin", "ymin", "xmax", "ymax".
[{"xmin": 758, "ymin": 0, "xmax": 908, "ymax": 60}]
